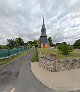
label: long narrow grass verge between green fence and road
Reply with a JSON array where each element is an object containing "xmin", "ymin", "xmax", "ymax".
[{"xmin": 0, "ymin": 50, "xmax": 28, "ymax": 65}]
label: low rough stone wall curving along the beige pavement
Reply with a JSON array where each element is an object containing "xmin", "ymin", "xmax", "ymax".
[{"xmin": 38, "ymin": 53, "xmax": 80, "ymax": 72}]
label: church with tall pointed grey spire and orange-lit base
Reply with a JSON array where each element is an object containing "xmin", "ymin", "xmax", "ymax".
[{"xmin": 40, "ymin": 17, "xmax": 48, "ymax": 48}]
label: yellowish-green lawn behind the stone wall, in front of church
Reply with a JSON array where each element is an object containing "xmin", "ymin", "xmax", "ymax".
[{"xmin": 38, "ymin": 48, "xmax": 80, "ymax": 59}]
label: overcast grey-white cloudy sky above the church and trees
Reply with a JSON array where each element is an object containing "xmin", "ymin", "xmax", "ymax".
[{"xmin": 0, "ymin": 0, "xmax": 80, "ymax": 45}]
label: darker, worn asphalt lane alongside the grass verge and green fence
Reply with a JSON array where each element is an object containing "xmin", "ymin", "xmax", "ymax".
[{"xmin": 0, "ymin": 49, "xmax": 34, "ymax": 92}]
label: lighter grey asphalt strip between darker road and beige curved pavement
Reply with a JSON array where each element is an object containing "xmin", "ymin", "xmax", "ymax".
[{"xmin": 16, "ymin": 55, "xmax": 54, "ymax": 92}]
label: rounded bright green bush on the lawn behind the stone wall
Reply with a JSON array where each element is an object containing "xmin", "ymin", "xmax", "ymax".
[{"xmin": 58, "ymin": 42, "xmax": 73, "ymax": 55}]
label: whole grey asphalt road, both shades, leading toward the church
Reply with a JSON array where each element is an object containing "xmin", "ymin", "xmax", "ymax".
[{"xmin": 0, "ymin": 49, "xmax": 80, "ymax": 92}]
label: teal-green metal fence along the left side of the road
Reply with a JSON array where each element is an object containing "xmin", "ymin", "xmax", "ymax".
[{"xmin": 0, "ymin": 47, "xmax": 27, "ymax": 58}]
